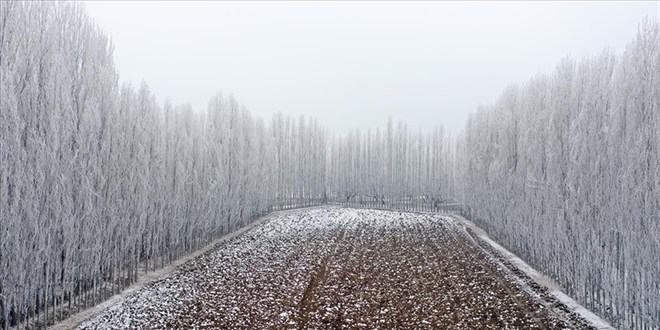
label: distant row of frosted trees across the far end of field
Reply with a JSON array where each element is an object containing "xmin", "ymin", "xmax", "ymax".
[{"xmin": 326, "ymin": 120, "xmax": 455, "ymax": 211}]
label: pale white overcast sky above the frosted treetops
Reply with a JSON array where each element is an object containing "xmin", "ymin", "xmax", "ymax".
[{"xmin": 87, "ymin": 1, "xmax": 660, "ymax": 133}]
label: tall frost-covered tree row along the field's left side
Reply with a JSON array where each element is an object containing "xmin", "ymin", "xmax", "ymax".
[{"xmin": 0, "ymin": 2, "xmax": 326, "ymax": 328}]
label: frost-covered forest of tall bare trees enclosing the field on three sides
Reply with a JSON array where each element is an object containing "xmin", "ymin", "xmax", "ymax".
[{"xmin": 0, "ymin": 1, "xmax": 660, "ymax": 329}]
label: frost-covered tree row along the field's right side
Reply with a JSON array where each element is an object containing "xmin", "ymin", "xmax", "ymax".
[{"xmin": 455, "ymin": 21, "xmax": 660, "ymax": 329}]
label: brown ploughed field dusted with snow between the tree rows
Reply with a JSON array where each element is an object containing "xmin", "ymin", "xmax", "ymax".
[{"xmin": 79, "ymin": 207, "xmax": 590, "ymax": 329}]
